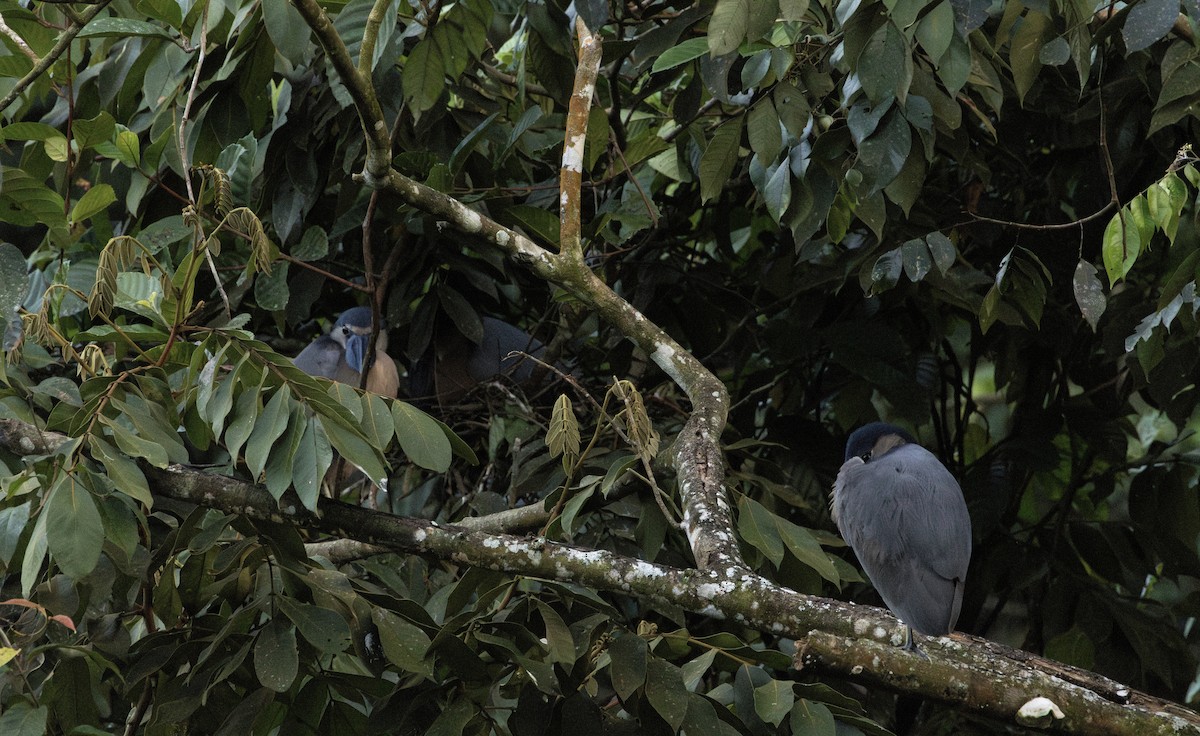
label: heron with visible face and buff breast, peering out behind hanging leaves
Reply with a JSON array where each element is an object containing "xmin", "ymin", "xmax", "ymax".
[{"xmin": 293, "ymin": 306, "xmax": 400, "ymax": 397}]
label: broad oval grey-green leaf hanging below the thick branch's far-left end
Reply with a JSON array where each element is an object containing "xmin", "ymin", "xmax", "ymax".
[{"xmin": 43, "ymin": 473, "xmax": 104, "ymax": 580}]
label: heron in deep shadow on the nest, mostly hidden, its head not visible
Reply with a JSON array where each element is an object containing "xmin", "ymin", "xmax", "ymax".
[{"xmin": 408, "ymin": 317, "xmax": 546, "ymax": 405}]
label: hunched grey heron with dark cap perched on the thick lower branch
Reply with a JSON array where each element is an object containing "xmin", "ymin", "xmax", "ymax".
[{"xmin": 830, "ymin": 421, "xmax": 971, "ymax": 650}]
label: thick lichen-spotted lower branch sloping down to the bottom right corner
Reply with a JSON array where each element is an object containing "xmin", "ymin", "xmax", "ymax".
[{"xmin": 0, "ymin": 419, "xmax": 1200, "ymax": 736}]
